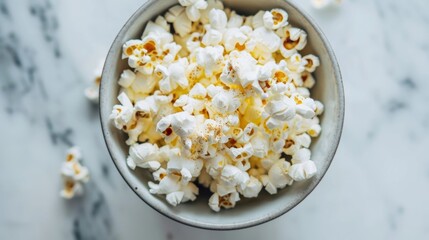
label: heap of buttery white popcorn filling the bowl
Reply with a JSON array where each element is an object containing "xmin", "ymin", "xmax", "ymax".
[{"xmin": 110, "ymin": 0, "xmax": 323, "ymax": 211}]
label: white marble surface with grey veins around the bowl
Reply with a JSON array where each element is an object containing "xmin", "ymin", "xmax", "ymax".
[{"xmin": 0, "ymin": 0, "xmax": 429, "ymax": 240}]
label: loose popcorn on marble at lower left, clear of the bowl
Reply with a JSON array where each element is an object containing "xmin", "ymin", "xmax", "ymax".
[{"xmin": 60, "ymin": 147, "xmax": 89, "ymax": 199}]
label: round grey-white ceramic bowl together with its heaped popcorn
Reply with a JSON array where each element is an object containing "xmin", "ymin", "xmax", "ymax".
[{"xmin": 100, "ymin": 0, "xmax": 344, "ymax": 229}]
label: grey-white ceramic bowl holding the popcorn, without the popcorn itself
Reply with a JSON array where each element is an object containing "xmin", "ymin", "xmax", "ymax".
[{"xmin": 100, "ymin": 0, "xmax": 344, "ymax": 230}]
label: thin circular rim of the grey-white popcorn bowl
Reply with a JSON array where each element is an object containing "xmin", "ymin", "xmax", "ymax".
[{"xmin": 99, "ymin": 0, "xmax": 345, "ymax": 230}]
